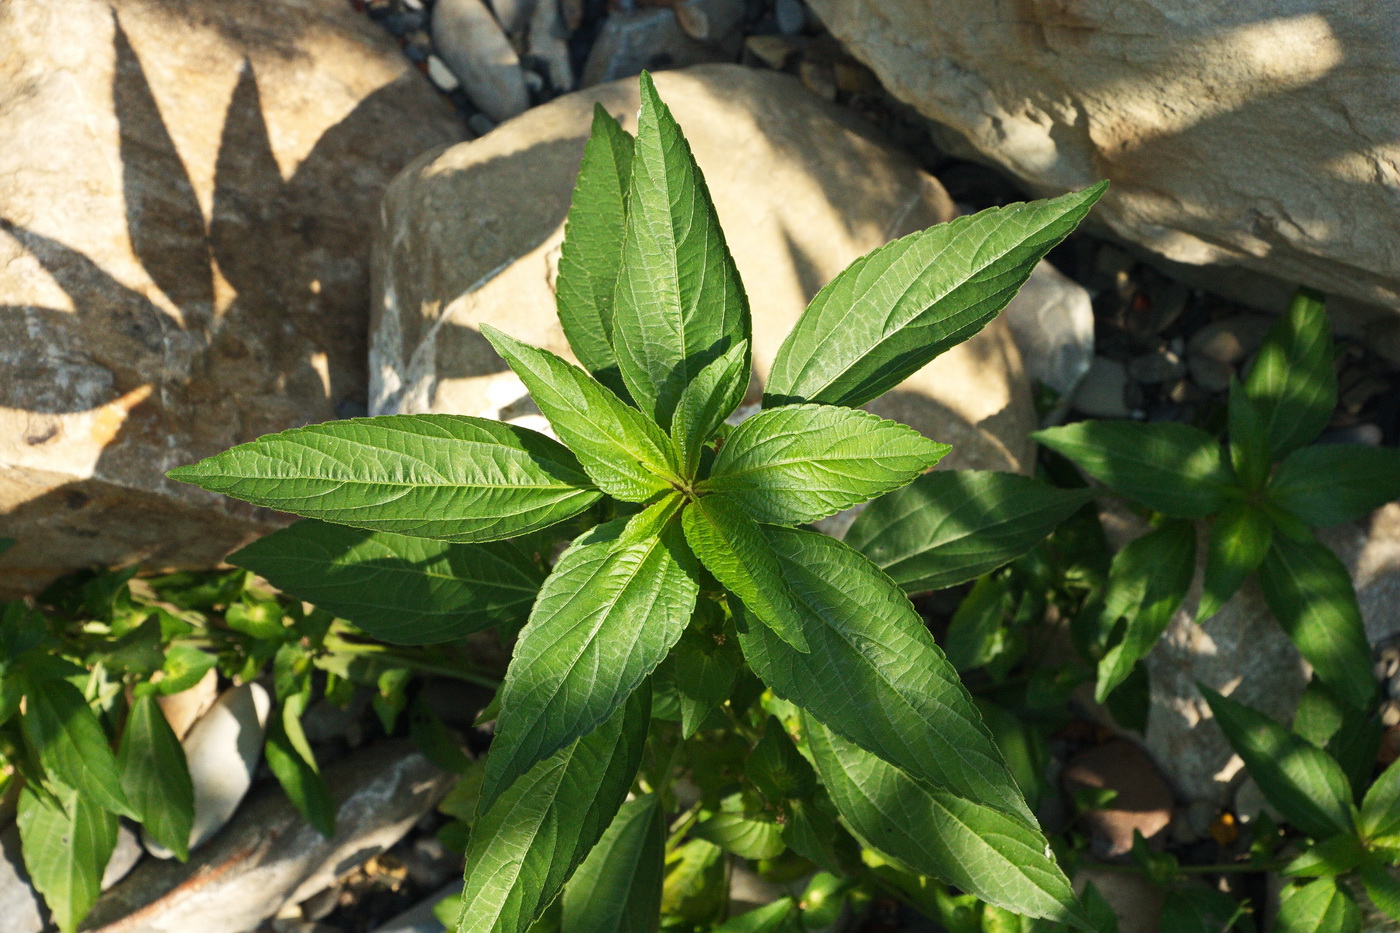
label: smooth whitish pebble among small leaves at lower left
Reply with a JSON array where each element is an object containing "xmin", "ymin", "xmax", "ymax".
[{"xmin": 141, "ymin": 684, "xmax": 272, "ymax": 859}]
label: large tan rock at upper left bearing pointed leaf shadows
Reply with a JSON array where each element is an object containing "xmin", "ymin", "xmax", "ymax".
[{"xmin": 0, "ymin": 0, "xmax": 462, "ymax": 594}]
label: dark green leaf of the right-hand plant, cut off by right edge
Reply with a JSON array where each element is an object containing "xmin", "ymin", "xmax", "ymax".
[{"xmin": 1268, "ymin": 444, "xmax": 1400, "ymax": 528}]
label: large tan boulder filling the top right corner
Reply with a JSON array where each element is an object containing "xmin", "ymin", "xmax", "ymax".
[{"xmin": 811, "ymin": 0, "xmax": 1400, "ymax": 316}]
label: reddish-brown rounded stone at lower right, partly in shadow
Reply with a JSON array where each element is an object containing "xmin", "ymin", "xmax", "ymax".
[{"xmin": 1060, "ymin": 740, "xmax": 1172, "ymax": 859}]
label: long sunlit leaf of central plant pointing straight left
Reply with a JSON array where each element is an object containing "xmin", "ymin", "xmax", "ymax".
[{"xmin": 168, "ymin": 415, "xmax": 599, "ymax": 542}]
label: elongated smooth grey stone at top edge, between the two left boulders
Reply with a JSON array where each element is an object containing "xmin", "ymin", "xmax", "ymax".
[{"xmin": 433, "ymin": 0, "xmax": 529, "ymax": 122}]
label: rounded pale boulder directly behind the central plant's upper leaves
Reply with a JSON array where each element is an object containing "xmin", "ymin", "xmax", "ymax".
[{"xmin": 370, "ymin": 66, "xmax": 1033, "ymax": 469}]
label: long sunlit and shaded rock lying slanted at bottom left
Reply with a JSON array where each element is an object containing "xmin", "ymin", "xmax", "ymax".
[{"xmin": 84, "ymin": 742, "xmax": 452, "ymax": 933}]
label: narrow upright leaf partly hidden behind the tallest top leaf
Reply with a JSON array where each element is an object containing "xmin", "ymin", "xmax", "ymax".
[{"xmin": 554, "ymin": 104, "xmax": 633, "ymax": 395}]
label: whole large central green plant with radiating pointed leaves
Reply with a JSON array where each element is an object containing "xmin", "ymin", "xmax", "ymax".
[{"xmin": 171, "ymin": 76, "xmax": 1103, "ymax": 933}]
